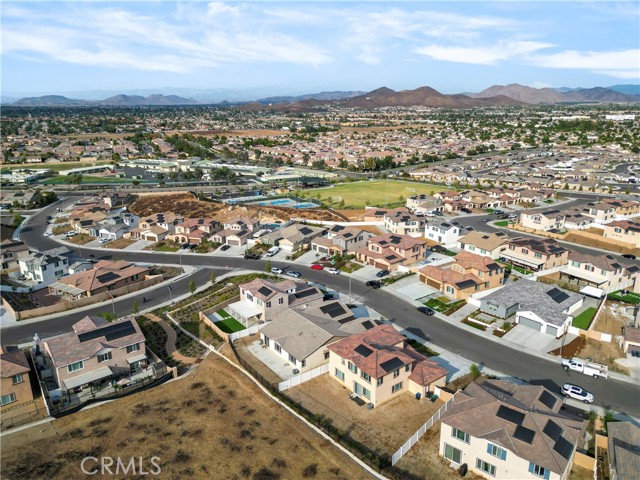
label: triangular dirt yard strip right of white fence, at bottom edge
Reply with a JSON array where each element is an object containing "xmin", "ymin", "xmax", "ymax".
[{"xmin": 396, "ymin": 422, "xmax": 482, "ymax": 480}]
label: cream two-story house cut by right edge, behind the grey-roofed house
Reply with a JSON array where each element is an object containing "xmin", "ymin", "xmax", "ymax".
[{"xmin": 560, "ymin": 251, "xmax": 640, "ymax": 293}]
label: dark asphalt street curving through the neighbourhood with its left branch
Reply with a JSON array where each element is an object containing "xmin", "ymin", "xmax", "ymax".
[{"xmin": 2, "ymin": 195, "xmax": 640, "ymax": 417}]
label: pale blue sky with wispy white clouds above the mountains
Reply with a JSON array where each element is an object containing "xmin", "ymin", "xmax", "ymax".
[{"xmin": 0, "ymin": 0, "xmax": 640, "ymax": 100}]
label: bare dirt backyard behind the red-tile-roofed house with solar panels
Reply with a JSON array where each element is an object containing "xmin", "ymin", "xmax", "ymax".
[{"xmin": 285, "ymin": 375, "xmax": 443, "ymax": 456}]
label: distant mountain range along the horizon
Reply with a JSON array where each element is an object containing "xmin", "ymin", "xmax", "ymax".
[{"xmin": 6, "ymin": 83, "xmax": 640, "ymax": 111}]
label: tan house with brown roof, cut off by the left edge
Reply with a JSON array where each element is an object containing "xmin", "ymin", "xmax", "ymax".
[{"xmin": 0, "ymin": 346, "xmax": 33, "ymax": 412}]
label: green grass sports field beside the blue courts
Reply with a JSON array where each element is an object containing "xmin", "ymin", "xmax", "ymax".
[{"xmin": 301, "ymin": 180, "xmax": 448, "ymax": 209}]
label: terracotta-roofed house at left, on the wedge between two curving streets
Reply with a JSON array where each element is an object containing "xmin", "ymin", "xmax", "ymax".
[{"xmin": 49, "ymin": 260, "xmax": 149, "ymax": 300}]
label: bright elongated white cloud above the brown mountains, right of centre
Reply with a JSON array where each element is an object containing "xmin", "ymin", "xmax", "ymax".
[{"xmin": 415, "ymin": 40, "xmax": 553, "ymax": 65}]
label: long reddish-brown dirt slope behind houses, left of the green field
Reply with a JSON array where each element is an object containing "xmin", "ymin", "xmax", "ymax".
[{"xmin": 129, "ymin": 193, "xmax": 343, "ymax": 223}]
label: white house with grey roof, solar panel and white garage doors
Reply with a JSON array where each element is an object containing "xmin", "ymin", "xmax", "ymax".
[{"xmin": 480, "ymin": 279, "xmax": 584, "ymax": 338}]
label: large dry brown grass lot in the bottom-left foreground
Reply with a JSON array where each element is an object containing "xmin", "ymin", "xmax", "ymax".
[{"xmin": 2, "ymin": 356, "xmax": 370, "ymax": 480}]
